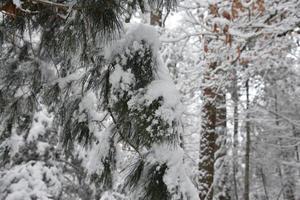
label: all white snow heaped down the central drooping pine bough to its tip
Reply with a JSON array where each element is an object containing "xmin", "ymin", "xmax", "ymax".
[{"xmin": 103, "ymin": 25, "xmax": 198, "ymax": 200}]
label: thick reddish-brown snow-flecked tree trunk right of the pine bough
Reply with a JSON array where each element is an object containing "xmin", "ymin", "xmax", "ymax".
[{"xmin": 198, "ymin": 6, "xmax": 230, "ymax": 197}]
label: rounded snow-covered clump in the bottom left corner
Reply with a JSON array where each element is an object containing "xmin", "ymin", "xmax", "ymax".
[{"xmin": 0, "ymin": 161, "xmax": 61, "ymax": 200}]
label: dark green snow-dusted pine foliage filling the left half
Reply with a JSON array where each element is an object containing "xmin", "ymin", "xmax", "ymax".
[{"xmin": 0, "ymin": 0, "xmax": 199, "ymax": 200}]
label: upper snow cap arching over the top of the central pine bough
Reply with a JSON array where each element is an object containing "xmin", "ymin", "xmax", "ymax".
[{"xmin": 106, "ymin": 24, "xmax": 182, "ymax": 123}]
